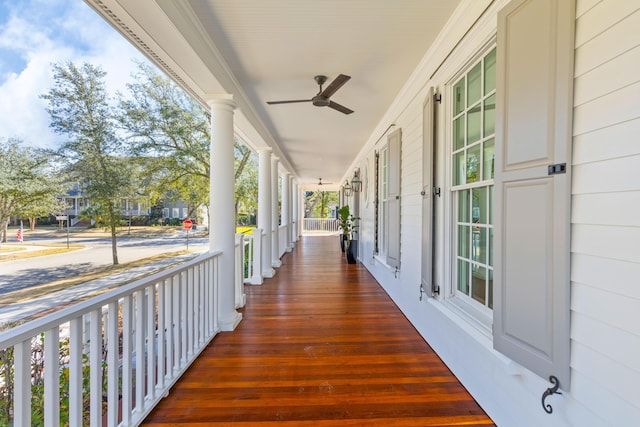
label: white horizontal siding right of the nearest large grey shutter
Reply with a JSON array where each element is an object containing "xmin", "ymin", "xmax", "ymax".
[{"xmin": 571, "ymin": 0, "xmax": 640, "ymax": 425}]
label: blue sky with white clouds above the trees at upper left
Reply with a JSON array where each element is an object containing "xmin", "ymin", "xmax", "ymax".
[{"xmin": 0, "ymin": 0, "xmax": 148, "ymax": 148}]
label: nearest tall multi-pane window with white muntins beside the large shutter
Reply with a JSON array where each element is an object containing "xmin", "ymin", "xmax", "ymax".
[{"xmin": 451, "ymin": 47, "xmax": 496, "ymax": 309}]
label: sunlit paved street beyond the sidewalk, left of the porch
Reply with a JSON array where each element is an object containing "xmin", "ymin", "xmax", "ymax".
[{"xmin": 0, "ymin": 230, "xmax": 208, "ymax": 295}]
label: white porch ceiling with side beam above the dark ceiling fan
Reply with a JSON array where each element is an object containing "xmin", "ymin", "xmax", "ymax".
[{"xmin": 86, "ymin": 0, "xmax": 460, "ymax": 188}]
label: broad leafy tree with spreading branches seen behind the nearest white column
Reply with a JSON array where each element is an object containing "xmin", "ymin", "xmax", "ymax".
[{"xmin": 118, "ymin": 64, "xmax": 258, "ymax": 227}]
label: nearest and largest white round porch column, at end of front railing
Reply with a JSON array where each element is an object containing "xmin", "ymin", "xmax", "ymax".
[{"xmin": 208, "ymin": 95, "xmax": 242, "ymax": 331}]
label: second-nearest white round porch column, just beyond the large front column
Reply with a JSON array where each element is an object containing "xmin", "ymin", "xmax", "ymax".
[{"xmin": 258, "ymin": 148, "xmax": 275, "ymax": 279}]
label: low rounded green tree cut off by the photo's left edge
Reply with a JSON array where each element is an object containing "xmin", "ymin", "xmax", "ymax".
[{"xmin": 0, "ymin": 138, "xmax": 62, "ymax": 243}]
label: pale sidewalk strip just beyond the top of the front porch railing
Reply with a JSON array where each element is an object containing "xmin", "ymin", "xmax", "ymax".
[{"xmin": 0, "ymin": 253, "xmax": 198, "ymax": 325}]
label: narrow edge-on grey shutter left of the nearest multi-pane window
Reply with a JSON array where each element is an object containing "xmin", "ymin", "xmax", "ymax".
[{"xmin": 421, "ymin": 87, "xmax": 435, "ymax": 295}]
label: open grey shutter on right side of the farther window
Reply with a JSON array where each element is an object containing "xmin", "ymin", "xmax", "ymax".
[{"xmin": 385, "ymin": 129, "xmax": 402, "ymax": 268}]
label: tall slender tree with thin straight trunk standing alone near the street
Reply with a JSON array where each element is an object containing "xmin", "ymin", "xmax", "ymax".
[{"xmin": 42, "ymin": 62, "xmax": 134, "ymax": 265}]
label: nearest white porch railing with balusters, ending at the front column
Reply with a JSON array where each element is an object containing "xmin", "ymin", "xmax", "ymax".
[{"xmin": 0, "ymin": 252, "xmax": 220, "ymax": 427}]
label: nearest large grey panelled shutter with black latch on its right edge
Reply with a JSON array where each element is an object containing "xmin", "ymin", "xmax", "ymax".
[{"xmin": 494, "ymin": 0, "xmax": 575, "ymax": 389}]
